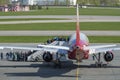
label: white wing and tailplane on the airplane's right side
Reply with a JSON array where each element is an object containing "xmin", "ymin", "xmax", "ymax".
[{"xmin": 84, "ymin": 44, "xmax": 120, "ymax": 54}]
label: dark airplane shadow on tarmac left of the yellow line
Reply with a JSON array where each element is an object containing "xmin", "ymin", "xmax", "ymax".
[{"xmin": 3, "ymin": 61, "xmax": 77, "ymax": 78}]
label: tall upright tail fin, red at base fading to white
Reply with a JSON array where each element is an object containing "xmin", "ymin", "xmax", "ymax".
[{"xmin": 76, "ymin": 4, "xmax": 80, "ymax": 46}]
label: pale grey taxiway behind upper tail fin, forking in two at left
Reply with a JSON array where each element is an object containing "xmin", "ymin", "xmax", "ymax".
[{"xmin": 0, "ymin": 15, "xmax": 120, "ymax": 24}]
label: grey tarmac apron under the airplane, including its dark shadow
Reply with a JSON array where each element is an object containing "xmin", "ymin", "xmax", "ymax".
[{"xmin": 0, "ymin": 43, "xmax": 120, "ymax": 80}]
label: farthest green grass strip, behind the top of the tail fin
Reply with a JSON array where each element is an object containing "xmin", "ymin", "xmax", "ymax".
[{"xmin": 0, "ymin": 8, "xmax": 120, "ymax": 16}]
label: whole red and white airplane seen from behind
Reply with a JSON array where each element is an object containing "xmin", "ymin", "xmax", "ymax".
[{"xmin": 0, "ymin": 4, "xmax": 120, "ymax": 67}]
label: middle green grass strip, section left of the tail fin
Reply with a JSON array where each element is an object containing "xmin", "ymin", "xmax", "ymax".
[{"xmin": 0, "ymin": 23, "xmax": 75, "ymax": 30}]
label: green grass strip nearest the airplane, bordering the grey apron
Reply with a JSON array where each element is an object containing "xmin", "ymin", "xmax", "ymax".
[{"xmin": 0, "ymin": 36, "xmax": 120, "ymax": 43}]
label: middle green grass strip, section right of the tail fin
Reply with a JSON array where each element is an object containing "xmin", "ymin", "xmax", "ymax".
[{"xmin": 81, "ymin": 22, "xmax": 120, "ymax": 30}]
